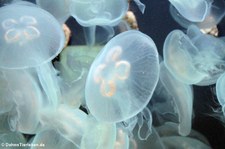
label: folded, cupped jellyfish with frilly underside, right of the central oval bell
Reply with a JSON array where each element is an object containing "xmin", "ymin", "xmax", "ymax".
[{"xmin": 163, "ymin": 26, "xmax": 225, "ymax": 86}]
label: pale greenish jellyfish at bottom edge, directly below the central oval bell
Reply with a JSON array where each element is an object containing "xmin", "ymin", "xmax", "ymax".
[{"xmin": 80, "ymin": 116, "xmax": 116, "ymax": 149}]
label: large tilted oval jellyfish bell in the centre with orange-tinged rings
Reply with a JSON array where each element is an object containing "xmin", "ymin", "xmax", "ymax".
[{"xmin": 85, "ymin": 31, "xmax": 159, "ymax": 122}]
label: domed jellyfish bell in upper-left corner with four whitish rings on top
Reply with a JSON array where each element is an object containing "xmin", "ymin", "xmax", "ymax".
[{"xmin": 0, "ymin": 3, "xmax": 65, "ymax": 69}]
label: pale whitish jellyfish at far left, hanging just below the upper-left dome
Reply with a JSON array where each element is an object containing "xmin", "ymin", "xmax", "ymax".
[{"xmin": 4, "ymin": 70, "xmax": 43, "ymax": 134}]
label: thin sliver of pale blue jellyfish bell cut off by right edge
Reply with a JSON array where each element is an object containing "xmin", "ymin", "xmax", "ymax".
[{"xmin": 216, "ymin": 73, "xmax": 225, "ymax": 116}]
